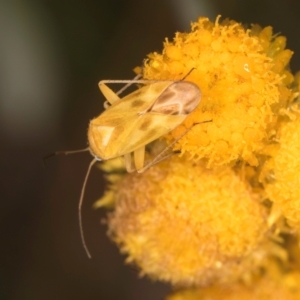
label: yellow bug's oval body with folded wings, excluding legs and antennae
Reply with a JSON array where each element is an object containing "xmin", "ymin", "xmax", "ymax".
[{"xmin": 88, "ymin": 81, "xmax": 201, "ymax": 160}]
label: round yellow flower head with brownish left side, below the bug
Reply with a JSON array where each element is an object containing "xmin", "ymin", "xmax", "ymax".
[{"xmin": 109, "ymin": 158, "xmax": 268, "ymax": 286}]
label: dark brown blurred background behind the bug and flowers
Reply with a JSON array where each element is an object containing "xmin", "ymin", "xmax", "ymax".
[{"xmin": 0, "ymin": 0, "xmax": 300, "ymax": 300}]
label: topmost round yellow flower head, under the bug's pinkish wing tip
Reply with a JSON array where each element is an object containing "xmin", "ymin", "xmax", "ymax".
[{"xmin": 143, "ymin": 18, "xmax": 293, "ymax": 165}]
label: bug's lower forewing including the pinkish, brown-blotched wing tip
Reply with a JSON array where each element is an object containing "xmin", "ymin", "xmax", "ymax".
[{"xmin": 103, "ymin": 81, "xmax": 201, "ymax": 155}]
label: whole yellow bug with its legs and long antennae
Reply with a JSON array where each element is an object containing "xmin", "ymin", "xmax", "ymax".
[{"xmin": 51, "ymin": 69, "xmax": 201, "ymax": 258}]
